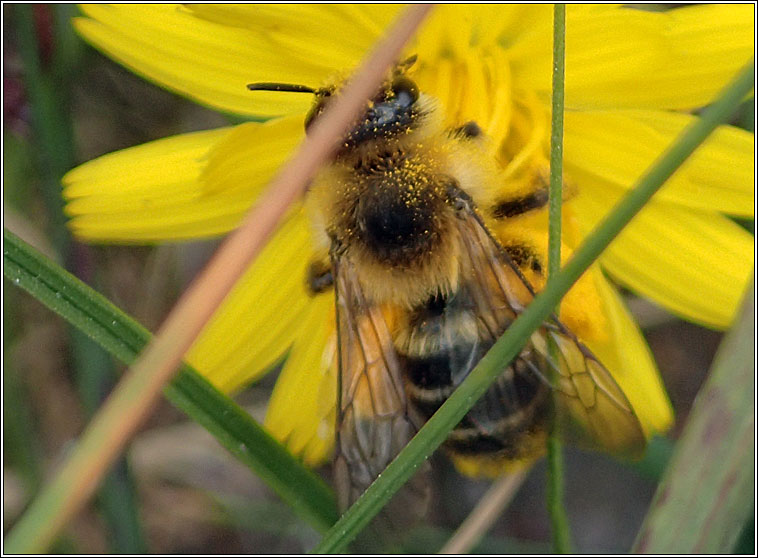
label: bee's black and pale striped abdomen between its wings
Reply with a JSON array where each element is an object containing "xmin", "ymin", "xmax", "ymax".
[{"xmin": 394, "ymin": 285, "xmax": 551, "ymax": 459}]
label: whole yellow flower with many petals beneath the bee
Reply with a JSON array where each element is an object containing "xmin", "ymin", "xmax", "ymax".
[{"xmin": 64, "ymin": 5, "xmax": 754, "ymax": 463}]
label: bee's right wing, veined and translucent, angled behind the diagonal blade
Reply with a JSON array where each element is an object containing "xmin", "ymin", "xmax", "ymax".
[{"xmin": 459, "ymin": 209, "xmax": 646, "ymax": 462}]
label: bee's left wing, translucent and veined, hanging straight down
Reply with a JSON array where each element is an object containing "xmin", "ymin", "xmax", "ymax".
[{"xmin": 333, "ymin": 259, "xmax": 428, "ymax": 515}]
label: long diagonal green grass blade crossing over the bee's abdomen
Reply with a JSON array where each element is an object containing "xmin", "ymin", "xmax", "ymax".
[{"xmin": 313, "ymin": 61, "xmax": 755, "ymax": 554}]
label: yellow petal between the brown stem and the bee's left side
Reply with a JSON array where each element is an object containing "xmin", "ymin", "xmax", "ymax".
[{"xmin": 187, "ymin": 210, "xmax": 311, "ymax": 391}]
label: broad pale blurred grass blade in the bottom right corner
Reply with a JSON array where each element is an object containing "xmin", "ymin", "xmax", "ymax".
[{"xmin": 634, "ymin": 278, "xmax": 755, "ymax": 554}]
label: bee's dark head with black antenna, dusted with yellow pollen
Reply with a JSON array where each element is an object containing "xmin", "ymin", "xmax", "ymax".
[{"xmin": 247, "ymin": 56, "xmax": 423, "ymax": 148}]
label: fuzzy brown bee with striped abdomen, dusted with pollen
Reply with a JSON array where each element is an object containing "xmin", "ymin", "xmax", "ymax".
[{"xmin": 248, "ymin": 55, "xmax": 645, "ymax": 509}]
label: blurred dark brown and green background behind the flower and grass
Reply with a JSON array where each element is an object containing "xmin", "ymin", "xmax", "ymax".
[{"xmin": 3, "ymin": 4, "xmax": 754, "ymax": 554}]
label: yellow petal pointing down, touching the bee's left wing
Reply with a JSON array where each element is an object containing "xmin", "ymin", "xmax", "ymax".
[{"xmin": 265, "ymin": 293, "xmax": 337, "ymax": 464}]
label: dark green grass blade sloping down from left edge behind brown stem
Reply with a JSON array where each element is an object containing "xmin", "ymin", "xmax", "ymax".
[{"xmin": 3, "ymin": 230, "xmax": 336, "ymax": 553}]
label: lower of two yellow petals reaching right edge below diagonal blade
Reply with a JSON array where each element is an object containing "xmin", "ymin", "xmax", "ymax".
[{"xmin": 572, "ymin": 177, "xmax": 754, "ymax": 328}]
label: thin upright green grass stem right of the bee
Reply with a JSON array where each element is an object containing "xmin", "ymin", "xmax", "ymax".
[{"xmin": 547, "ymin": 4, "xmax": 571, "ymax": 554}]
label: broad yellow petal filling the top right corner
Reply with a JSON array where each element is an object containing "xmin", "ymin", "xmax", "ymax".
[{"xmin": 512, "ymin": 4, "xmax": 754, "ymax": 109}]
